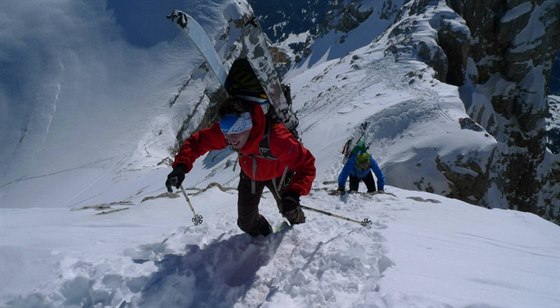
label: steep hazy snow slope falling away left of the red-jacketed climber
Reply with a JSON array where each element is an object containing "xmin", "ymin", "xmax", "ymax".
[{"xmin": 0, "ymin": 0, "xmax": 237, "ymax": 207}]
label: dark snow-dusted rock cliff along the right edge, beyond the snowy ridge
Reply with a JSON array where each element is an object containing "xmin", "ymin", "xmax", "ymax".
[{"xmin": 447, "ymin": 0, "xmax": 560, "ymax": 216}]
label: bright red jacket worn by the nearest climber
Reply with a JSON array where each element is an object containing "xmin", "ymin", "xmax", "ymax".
[{"xmin": 173, "ymin": 104, "xmax": 315, "ymax": 196}]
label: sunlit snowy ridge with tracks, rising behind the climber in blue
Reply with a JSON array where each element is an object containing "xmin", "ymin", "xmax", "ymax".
[{"xmin": 289, "ymin": 44, "xmax": 496, "ymax": 194}]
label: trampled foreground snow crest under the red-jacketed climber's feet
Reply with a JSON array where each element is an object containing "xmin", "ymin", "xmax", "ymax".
[{"xmin": 0, "ymin": 187, "xmax": 560, "ymax": 307}]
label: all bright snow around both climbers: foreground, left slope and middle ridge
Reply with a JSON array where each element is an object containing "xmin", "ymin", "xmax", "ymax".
[{"xmin": 0, "ymin": 0, "xmax": 560, "ymax": 307}]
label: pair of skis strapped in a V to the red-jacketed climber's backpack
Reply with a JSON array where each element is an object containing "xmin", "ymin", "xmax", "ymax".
[{"xmin": 167, "ymin": 10, "xmax": 299, "ymax": 139}]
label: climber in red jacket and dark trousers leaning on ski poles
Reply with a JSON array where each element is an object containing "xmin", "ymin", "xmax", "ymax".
[{"xmin": 165, "ymin": 98, "xmax": 315, "ymax": 236}]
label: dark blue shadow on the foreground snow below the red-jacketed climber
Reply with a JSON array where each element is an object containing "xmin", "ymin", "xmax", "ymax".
[{"xmin": 139, "ymin": 233, "xmax": 284, "ymax": 307}]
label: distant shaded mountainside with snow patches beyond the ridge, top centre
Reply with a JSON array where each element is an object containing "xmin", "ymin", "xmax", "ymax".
[{"xmin": 252, "ymin": 0, "xmax": 405, "ymax": 68}]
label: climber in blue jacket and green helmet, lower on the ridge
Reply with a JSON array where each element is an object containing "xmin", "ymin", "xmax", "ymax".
[{"xmin": 338, "ymin": 152, "xmax": 385, "ymax": 193}]
